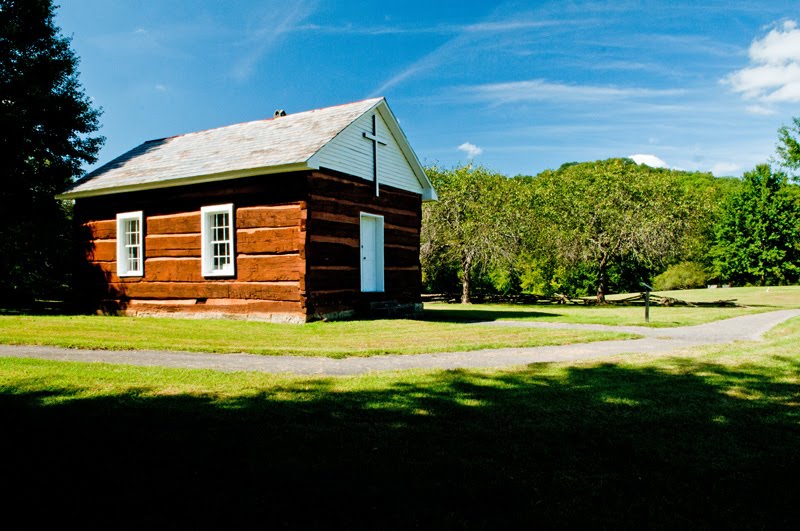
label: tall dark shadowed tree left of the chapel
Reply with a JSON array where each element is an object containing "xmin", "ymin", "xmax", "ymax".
[{"xmin": 0, "ymin": 0, "xmax": 103, "ymax": 303}]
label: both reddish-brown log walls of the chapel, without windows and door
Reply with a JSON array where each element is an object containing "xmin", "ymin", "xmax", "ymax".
[{"xmin": 75, "ymin": 170, "xmax": 422, "ymax": 321}]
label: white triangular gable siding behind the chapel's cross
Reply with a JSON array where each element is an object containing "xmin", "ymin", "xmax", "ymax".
[{"xmin": 316, "ymin": 109, "xmax": 423, "ymax": 193}]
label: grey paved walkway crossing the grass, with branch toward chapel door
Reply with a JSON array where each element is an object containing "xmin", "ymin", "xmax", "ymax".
[{"xmin": 0, "ymin": 310, "xmax": 800, "ymax": 375}]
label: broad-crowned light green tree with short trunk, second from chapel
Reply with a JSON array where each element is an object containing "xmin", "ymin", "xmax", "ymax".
[{"xmin": 532, "ymin": 159, "xmax": 707, "ymax": 303}]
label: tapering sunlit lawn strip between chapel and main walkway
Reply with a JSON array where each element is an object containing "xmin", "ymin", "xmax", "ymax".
[{"xmin": 0, "ymin": 315, "xmax": 634, "ymax": 358}]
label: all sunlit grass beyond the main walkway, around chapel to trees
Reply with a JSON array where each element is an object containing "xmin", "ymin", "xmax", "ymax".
[{"xmin": 0, "ymin": 286, "xmax": 800, "ymax": 358}]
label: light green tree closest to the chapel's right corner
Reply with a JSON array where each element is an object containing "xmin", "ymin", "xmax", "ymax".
[{"xmin": 421, "ymin": 165, "xmax": 526, "ymax": 303}]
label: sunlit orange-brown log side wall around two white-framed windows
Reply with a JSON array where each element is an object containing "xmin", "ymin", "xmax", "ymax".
[{"xmin": 71, "ymin": 173, "xmax": 307, "ymax": 322}]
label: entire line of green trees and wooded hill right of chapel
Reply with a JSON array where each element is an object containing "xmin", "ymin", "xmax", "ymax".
[{"xmin": 421, "ymin": 124, "xmax": 800, "ymax": 302}]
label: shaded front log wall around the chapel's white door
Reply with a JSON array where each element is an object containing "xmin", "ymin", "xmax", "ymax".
[{"xmin": 306, "ymin": 170, "xmax": 422, "ymax": 318}]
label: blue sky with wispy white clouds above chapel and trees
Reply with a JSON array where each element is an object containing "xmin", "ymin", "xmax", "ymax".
[{"xmin": 56, "ymin": 0, "xmax": 800, "ymax": 180}]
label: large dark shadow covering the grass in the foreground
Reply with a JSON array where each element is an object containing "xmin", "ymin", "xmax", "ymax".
[{"xmin": 0, "ymin": 361, "xmax": 800, "ymax": 529}]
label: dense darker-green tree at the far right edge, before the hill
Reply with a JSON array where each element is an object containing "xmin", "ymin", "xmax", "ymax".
[{"xmin": 712, "ymin": 164, "xmax": 800, "ymax": 286}]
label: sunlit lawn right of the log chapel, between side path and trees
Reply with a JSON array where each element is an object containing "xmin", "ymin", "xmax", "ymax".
[{"xmin": 425, "ymin": 286, "xmax": 800, "ymax": 327}]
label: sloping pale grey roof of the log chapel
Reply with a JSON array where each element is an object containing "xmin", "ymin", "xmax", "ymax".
[{"xmin": 59, "ymin": 98, "xmax": 385, "ymax": 199}]
